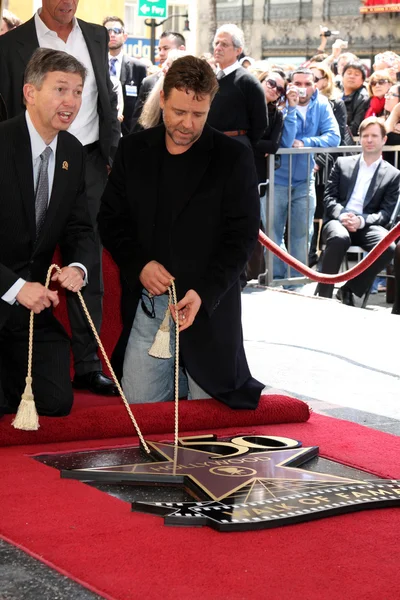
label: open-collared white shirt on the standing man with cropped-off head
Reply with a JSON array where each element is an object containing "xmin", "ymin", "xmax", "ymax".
[{"xmin": 35, "ymin": 9, "xmax": 99, "ymax": 146}]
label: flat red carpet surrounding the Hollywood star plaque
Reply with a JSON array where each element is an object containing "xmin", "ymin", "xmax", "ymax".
[{"xmin": 0, "ymin": 415, "xmax": 400, "ymax": 600}]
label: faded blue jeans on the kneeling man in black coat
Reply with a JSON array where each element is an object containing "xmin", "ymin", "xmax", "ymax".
[{"xmin": 122, "ymin": 294, "xmax": 210, "ymax": 404}]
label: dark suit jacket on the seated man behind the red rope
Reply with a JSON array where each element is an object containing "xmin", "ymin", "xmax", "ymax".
[{"xmin": 324, "ymin": 156, "xmax": 400, "ymax": 227}]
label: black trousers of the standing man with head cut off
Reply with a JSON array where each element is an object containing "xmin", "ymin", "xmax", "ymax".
[{"xmin": 67, "ymin": 148, "xmax": 107, "ymax": 375}]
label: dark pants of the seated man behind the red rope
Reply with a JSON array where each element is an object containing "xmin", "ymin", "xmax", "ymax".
[{"xmin": 317, "ymin": 221, "xmax": 395, "ymax": 298}]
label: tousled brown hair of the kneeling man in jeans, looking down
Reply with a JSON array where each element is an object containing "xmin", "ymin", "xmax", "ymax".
[{"xmin": 163, "ymin": 56, "xmax": 219, "ymax": 101}]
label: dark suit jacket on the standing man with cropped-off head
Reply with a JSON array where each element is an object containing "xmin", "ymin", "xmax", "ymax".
[{"xmin": 0, "ymin": 18, "xmax": 121, "ymax": 162}]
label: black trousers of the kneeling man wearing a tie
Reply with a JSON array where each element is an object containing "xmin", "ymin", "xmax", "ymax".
[{"xmin": 0, "ymin": 305, "xmax": 73, "ymax": 417}]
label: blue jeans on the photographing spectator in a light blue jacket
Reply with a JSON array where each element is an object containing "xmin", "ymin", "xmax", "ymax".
[{"xmin": 274, "ymin": 176, "xmax": 316, "ymax": 279}]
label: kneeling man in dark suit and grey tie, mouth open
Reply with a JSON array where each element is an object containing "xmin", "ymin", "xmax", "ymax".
[{"xmin": 0, "ymin": 48, "xmax": 95, "ymax": 416}]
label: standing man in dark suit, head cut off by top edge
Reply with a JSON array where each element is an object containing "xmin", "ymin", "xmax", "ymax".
[{"xmin": 0, "ymin": 0, "xmax": 121, "ymax": 394}]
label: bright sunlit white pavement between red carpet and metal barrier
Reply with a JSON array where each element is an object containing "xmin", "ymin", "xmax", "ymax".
[{"xmin": 242, "ymin": 284, "xmax": 400, "ymax": 435}]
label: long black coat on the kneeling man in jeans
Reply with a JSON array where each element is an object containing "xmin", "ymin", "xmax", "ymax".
[{"xmin": 98, "ymin": 125, "xmax": 263, "ymax": 408}]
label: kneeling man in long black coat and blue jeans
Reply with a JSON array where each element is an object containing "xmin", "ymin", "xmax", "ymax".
[{"xmin": 99, "ymin": 56, "xmax": 263, "ymax": 408}]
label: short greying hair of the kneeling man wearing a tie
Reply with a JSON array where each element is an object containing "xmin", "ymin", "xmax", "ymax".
[{"xmin": 24, "ymin": 48, "xmax": 87, "ymax": 89}]
